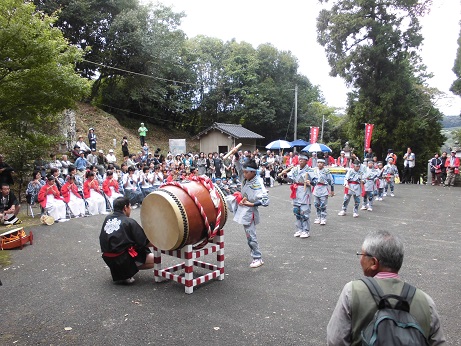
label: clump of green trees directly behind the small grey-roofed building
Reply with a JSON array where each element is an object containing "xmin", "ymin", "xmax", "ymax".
[{"xmin": 182, "ymin": 36, "xmax": 320, "ymax": 141}]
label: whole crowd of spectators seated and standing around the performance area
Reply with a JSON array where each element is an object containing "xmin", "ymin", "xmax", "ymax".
[{"xmin": 0, "ymin": 123, "xmax": 460, "ymax": 224}]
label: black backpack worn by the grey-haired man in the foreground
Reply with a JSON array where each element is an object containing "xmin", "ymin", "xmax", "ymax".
[{"xmin": 361, "ymin": 278, "xmax": 428, "ymax": 346}]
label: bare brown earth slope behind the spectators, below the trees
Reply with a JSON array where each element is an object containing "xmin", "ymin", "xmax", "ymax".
[{"xmin": 75, "ymin": 103, "xmax": 200, "ymax": 160}]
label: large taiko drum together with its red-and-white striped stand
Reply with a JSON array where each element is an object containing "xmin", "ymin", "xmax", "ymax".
[{"xmin": 141, "ymin": 177, "xmax": 228, "ymax": 294}]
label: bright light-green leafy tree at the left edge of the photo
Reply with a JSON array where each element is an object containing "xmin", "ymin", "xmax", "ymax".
[{"xmin": 0, "ymin": 0, "xmax": 89, "ymax": 199}]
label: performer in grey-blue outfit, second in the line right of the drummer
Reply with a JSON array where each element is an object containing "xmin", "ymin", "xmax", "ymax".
[{"xmin": 312, "ymin": 159, "xmax": 335, "ymax": 226}]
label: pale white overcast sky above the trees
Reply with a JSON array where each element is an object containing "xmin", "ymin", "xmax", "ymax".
[{"xmin": 152, "ymin": 0, "xmax": 461, "ymax": 115}]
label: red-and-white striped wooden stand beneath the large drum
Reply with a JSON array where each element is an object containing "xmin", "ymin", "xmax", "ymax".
[{"xmin": 154, "ymin": 229, "xmax": 224, "ymax": 294}]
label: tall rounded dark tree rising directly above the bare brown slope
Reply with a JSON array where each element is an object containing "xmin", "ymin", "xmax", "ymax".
[{"xmin": 96, "ymin": 5, "xmax": 191, "ymax": 127}]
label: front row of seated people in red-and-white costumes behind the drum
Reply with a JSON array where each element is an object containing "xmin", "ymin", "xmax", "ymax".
[{"xmin": 26, "ymin": 166, "xmax": 244, "ymax": 221}]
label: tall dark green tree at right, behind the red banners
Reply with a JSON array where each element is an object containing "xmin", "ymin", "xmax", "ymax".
[{"xmin": 317, "ymin": 0, "xmax": 444, "ymax": 178}]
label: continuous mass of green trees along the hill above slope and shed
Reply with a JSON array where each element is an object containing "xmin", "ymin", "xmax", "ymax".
[{"xmin": 35, "ymin": 0, "xmax": 322, "ymax": 141}]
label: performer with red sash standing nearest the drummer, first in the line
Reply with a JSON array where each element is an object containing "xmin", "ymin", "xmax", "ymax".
[{"xmin": 287, "ymin": 152, "xmax": 313, "ymax": 238}]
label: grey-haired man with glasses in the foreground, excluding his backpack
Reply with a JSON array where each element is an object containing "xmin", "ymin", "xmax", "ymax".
[{"xmin": 327, "ymin": 231, "xmax": 445, "ymax": 346}]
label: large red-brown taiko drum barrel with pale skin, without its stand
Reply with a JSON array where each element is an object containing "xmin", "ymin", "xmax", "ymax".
[{"xmin": 141, "ymin": 181, "xmax": 228, "ymax": 250}]
